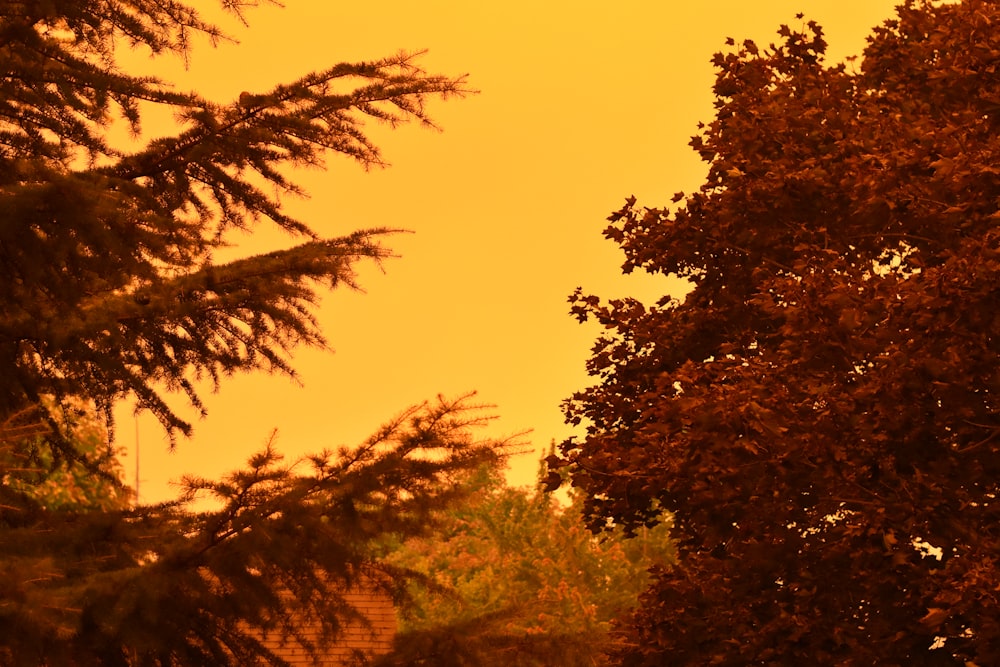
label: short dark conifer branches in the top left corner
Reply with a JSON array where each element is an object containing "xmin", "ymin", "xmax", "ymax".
[{"xmin": 0, "ymin": 0, "xmax": 209, "ymax": 161}]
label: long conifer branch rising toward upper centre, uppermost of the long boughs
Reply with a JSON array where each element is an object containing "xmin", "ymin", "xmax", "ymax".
[{"xmin": 99, "ymin": 53, "xmax": 471, "ymax": 233}]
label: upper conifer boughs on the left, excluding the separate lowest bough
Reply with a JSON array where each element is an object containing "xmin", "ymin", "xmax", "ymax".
[{"xmin": 0, "ymin": 0, "xmax": 463, "ymax": 448}]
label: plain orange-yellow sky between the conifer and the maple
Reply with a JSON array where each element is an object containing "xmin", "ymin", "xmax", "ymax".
[{"xmin": 118, "ymin": 0, "xmax": 896, "ymax": 502}]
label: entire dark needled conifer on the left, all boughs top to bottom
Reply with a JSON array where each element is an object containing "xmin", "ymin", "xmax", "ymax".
[{"xmin": 0, "ymin": 0, "xmax": 505, "ymax": 665}]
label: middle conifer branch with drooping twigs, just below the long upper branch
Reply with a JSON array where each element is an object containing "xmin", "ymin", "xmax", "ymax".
[{"xmin": 0, "ymin": 230, "xmax": 392, "ymax": 444}]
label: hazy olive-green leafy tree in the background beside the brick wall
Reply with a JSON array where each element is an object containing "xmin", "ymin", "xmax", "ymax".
[{"xmin": 379, "ymin": 465, "xmax": 673, "ymax": 666}]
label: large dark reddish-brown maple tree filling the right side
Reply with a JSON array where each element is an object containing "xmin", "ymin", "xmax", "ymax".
[{"xmin": 550, "ymin": 0, "xmax": 1000, "ymax": 665}]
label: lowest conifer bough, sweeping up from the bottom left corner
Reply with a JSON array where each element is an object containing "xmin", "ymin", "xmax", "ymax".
[{"xmin": 0, "ymin": 399, "xmax": 506, "ymax": 666}]
